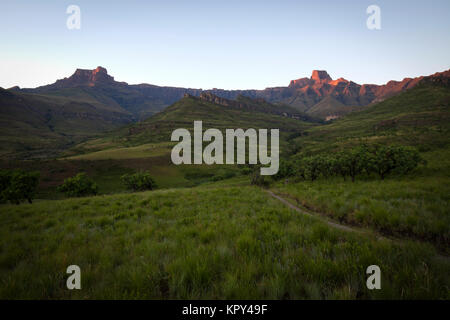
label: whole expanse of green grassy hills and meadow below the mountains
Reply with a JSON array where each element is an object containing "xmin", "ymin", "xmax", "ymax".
[{"xmin": 0, "ymin": 76, "xmax": 450, "ymax": 299}]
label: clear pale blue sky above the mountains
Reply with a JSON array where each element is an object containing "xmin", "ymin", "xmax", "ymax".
[{"xmin": 0, "ymin": 0, "xmax": 450, "ymax": 89}]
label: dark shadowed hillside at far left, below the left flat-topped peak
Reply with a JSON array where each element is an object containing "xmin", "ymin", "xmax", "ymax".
[{"xmin": 0, "ymin": 88, "xmax": 132, "ymax": 158}]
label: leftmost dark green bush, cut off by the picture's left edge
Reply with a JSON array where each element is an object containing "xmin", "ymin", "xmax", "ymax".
[{"xmin": 0, "ymin": 170, "xmax": 39, "ymax": 204}]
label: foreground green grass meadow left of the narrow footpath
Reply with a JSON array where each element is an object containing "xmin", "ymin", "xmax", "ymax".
[{"xmin": 0, "ymin": 186, "xmax": 449, "ymax": 299}]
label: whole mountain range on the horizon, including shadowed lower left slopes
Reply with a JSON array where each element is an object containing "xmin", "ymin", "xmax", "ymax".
[{"xmin": 0, "ymin": 67, "xmax": 450, "ymax": 158}]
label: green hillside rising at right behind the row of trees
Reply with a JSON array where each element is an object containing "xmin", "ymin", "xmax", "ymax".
[{"xmin": 297, "ymin": 77, "xmax": 450, "ymax": 153}]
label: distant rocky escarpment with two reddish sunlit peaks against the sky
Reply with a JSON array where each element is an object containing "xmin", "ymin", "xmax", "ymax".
[{"xmin": 19, "ymin": 67, "xmax": 444, "ymax": 120}]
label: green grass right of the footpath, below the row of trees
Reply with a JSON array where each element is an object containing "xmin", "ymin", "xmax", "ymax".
[{"xmin": 274, "ymin": 148, "xmax": 450, "ymax": 254}]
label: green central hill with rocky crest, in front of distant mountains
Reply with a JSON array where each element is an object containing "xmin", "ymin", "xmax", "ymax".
[{"xmin": 99, "ymin": 93, "xmax": 318, "ymax": 146}]
